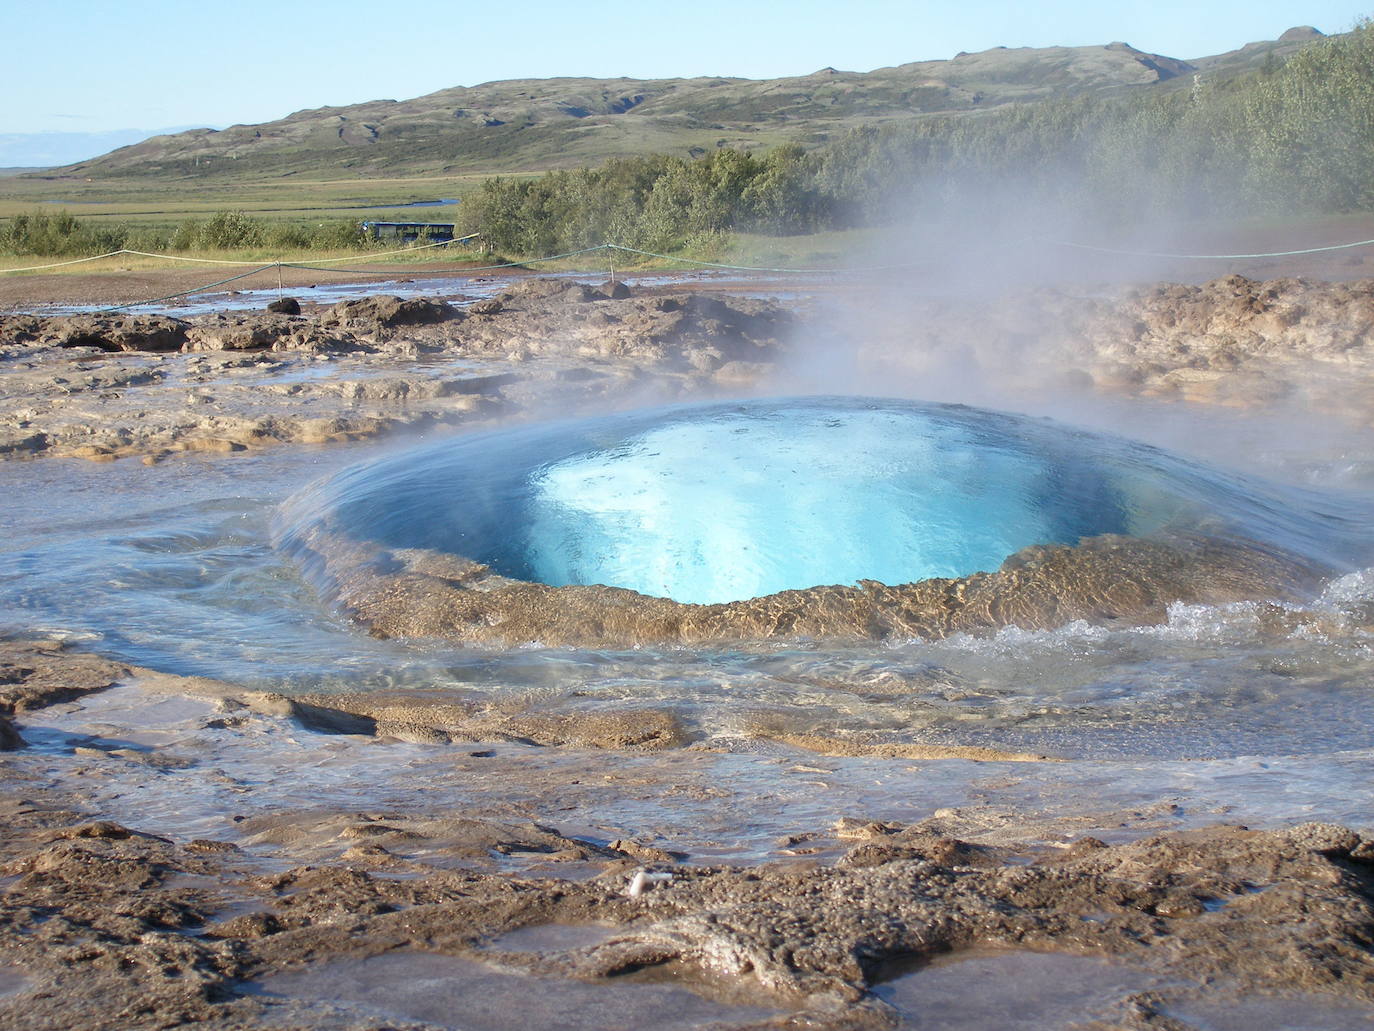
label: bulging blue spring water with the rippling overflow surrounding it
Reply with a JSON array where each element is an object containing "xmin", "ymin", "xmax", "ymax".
[{"xmin": 0, "ymin": 399, "xmax": 1374, "ymax": 756}]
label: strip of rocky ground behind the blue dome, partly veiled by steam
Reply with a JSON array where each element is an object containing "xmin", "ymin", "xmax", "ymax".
[{"xmin": 0, "ymin": 275, "xmax": 1374, "ymax": 461}]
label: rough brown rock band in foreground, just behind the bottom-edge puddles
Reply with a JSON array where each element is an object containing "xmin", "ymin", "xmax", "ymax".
[{"xmin": 0, "ymin": 780, "xmax": 1374, "ymax": 1031}]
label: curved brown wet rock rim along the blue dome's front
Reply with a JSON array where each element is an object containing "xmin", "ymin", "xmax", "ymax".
[{"xmin": 309, "ymin": 531, "xmax": 1323, "ymax": 646}]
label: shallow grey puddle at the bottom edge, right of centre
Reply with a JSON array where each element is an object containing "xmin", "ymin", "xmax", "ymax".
[{"xmin": 874, "ymin": 950, "xmax": 1159, "ymax": 1031}]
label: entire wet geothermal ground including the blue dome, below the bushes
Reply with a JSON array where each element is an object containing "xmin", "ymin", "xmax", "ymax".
[{"xmin": 0, "ymin": 252, "xmax": 1374, "ymax": 1031}]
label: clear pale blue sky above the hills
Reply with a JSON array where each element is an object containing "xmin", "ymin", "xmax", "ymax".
[{"xmin": 0, "ymin": 0, "xmax": 1374, "ymax": 133}]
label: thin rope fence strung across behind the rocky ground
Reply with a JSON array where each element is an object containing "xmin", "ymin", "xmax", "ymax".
[{"xmin": 0, "ymin": 234, "xmax": 1374, "ymax": 312}]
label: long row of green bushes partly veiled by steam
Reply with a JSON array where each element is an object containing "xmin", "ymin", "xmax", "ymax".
[{"xmin": 463, "ymin": 22, "xmax": 1374, "ymax": 257}]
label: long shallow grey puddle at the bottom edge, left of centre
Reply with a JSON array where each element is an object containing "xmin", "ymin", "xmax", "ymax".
[{"xmin": 245, "ymin": 951, "xmax": 778, "ymax": 1031}]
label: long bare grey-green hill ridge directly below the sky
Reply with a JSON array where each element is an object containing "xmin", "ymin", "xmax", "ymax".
[{"xmin": 45, "ymin": 29, "xmax": 1320, "ymax": 179}]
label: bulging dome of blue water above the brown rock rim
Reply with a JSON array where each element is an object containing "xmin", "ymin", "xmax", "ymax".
[{"xmin": 284, "ymin": 397, "xmax": 1363, "ymax": 621}]
